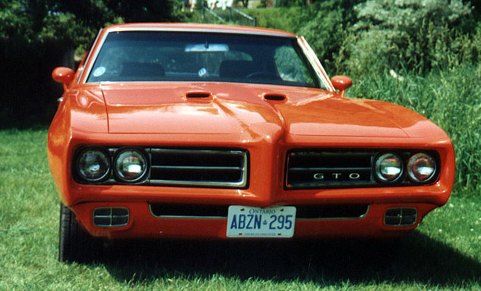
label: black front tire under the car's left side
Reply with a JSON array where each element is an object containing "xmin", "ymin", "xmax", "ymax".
[{"xmin": 58, "ymin": 204, "xmax": 103, "ymax": 263}]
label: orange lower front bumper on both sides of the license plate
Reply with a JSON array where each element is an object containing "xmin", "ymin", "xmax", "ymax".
[{"xmin": 73, "ymin": 202, "xmax": 436, "ymax": 239}]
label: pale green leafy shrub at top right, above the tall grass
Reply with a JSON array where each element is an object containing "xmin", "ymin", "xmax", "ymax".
[{"xmin": 342, "ymin": 0, "xmax": 481, "ymax": 75}]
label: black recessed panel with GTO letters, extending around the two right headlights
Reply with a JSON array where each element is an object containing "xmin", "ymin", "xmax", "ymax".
[{"xmin": 284, "ymin": 148, "xmax": 441, "ymax": 190}]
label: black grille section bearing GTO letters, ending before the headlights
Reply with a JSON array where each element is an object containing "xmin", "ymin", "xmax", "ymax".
[{"xmin": 285, "ymin": 150, "xmax": 376, "ymax": 189}]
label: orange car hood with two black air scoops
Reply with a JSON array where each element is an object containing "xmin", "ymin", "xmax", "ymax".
[{"xmin": 102, "ymin": 83, "xmax": 423, "ymax": 138}]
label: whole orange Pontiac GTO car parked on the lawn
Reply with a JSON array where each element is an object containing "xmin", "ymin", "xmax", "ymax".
[{"xmin": 48, "ymin": 24, "xmax": 455, "ymax": 261}]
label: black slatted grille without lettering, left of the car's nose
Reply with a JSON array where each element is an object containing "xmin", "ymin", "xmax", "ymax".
[{"xmin": 148, "ymin": 148, "xmax": 248, "ymax": 188}]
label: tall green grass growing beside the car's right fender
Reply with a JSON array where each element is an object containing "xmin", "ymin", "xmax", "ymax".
[{"xmin": 347, "ymin": 65, "xmax": 481, "ymax": 194}]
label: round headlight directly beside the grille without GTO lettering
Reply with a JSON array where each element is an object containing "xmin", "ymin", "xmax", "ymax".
[{"xmin": 115, "ymin": 149, "xmax": 148, "ymax": 183}]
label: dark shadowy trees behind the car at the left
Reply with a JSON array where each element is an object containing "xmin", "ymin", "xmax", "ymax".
[{"xmin": 0, "ymin": 0, "xmax": 180, "ymax": 124}]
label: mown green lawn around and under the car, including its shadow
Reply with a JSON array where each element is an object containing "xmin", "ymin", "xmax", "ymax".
[{"xmin": 0, "ymin": 130, "xmax": 481, "ymax": 290}]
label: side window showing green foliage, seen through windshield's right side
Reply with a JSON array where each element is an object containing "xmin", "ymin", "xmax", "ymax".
[{"xmin": 274, "ymin": 46, "xmax": 315, "ymax": 85}]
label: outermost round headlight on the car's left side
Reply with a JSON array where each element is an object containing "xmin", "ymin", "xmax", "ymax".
[{"xmin": 76, "ymin": 149, "xmax": 110, "ymax": 182}]
